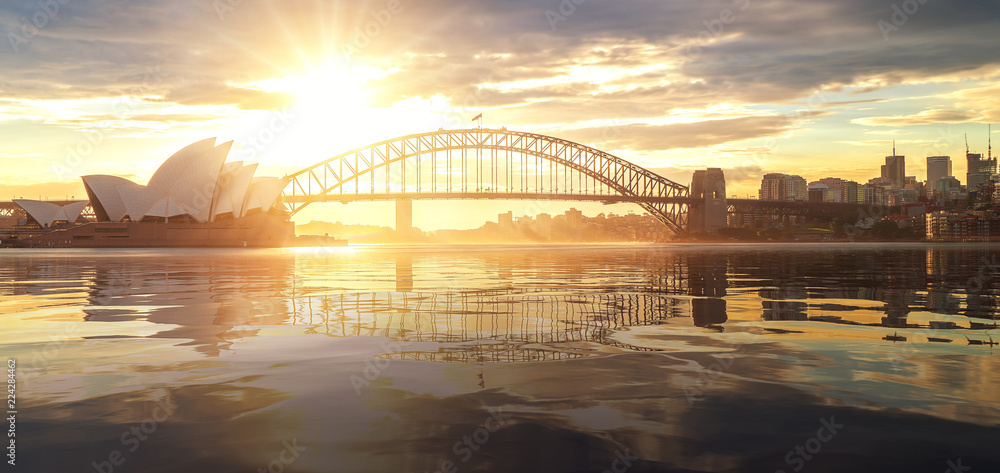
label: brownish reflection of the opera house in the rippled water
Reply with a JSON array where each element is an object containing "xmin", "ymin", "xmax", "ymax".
[{"xmin": 5, "ymin": 250, "xmax": 294, "ymax": 355}]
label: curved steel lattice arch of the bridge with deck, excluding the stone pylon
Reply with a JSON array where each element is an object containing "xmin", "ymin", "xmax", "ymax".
[{"xmin": 282, "ymin": 128, "xmax": 689, "ymax": 232}]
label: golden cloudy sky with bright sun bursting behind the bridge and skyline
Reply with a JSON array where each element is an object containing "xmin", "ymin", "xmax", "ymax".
[{"xmin": 0, "ymin": 0, "xmax": 1000, "ymax": 229}]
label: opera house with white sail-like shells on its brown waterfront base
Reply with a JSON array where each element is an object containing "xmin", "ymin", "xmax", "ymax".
[{"xmin": 4, "ymin": 138, "xmax": 294, "ymax": 248}]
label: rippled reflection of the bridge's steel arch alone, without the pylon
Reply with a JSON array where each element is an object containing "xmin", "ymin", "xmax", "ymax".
[{"xmin": 293, "ymin": 289, "xmax": 687, "ymax": 362}]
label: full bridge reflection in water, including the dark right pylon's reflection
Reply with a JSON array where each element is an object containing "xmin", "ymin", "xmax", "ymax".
[{"xmin": 280, "ymin": 253, "xmax": 727, "ymax": 362}]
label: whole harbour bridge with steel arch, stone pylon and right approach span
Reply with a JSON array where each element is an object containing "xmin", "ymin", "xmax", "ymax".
[{"xmin": 0, "ymin": 128, "xmax": 865, "ymax": 233}]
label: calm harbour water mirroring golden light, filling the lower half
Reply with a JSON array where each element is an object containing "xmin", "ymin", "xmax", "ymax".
[{"xmin": 0, "ymin": 244, "xmax": 1000, "ymax": 473}]
